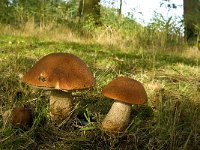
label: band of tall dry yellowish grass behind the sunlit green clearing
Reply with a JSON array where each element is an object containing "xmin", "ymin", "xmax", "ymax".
[{"xmin": 0, "ymin": 20, "xmax": 188, "ymax": 52}]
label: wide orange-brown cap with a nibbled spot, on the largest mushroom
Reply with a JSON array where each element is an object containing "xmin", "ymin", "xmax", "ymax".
[{"xmin": 23, "ymin": 53, "xmax": 95, "ymax": 90}]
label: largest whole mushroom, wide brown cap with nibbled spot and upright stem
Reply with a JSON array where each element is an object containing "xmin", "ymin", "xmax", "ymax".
[{"xmin": 23, "ymin": 53, "xmax": 95, "ymax": 120}]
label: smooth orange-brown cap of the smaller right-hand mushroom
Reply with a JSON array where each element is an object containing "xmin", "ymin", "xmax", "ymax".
[{"xmin": 102, "ymin": 77, "xmax": 147, "ymax": 104}]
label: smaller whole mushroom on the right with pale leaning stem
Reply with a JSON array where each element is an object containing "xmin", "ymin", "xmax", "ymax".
[{"xmin": 102, "ymin": 77, "xmax": 147, "ymax": 132}]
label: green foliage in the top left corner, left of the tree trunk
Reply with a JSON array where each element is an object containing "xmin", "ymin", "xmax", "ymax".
[{"xmin": 0, "ymin": 0, "xmax": 77, "ymax": 27}]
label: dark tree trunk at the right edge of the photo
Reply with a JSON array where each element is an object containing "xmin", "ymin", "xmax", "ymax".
[{"xmin": 183, "ymin": 0, "xmax": 200, "ymax": 43}]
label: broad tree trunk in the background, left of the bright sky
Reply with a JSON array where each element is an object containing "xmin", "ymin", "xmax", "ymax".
[{"xmin": 78, "ymin": 0, "xmax": 100, "ymax": 24}]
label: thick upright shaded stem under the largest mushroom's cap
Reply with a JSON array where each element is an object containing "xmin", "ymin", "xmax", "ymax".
[{"xmin": 50, "ymin": 90, "xmax": 72, "ymax": 120}]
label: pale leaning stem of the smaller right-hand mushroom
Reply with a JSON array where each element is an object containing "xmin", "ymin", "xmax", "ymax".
[{"xmin": 102, "ymin": 101, "xmax": 131, "ymax": 132}]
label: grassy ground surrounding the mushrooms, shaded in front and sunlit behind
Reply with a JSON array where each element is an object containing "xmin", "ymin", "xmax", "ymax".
[{"xmin": 0, "ymin": 26, "xmax": 200, "ymax": 150}]
